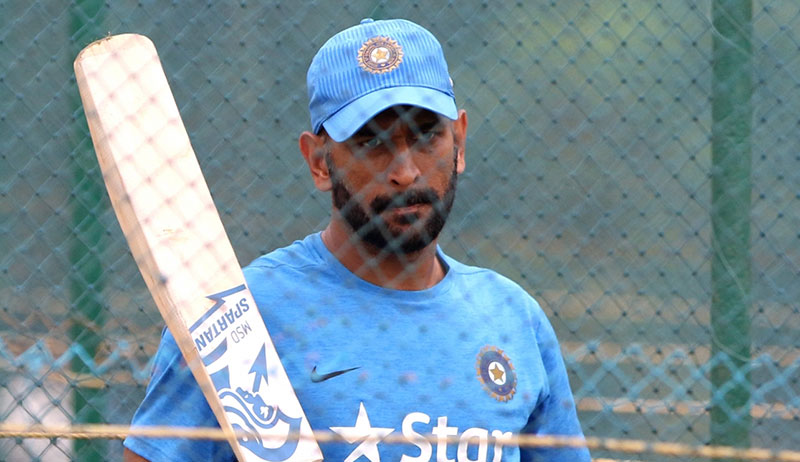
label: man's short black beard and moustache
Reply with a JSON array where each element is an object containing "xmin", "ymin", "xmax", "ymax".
[{"xmin": 325, "ymin": 150, "xmax": 458, "ymax": 255}]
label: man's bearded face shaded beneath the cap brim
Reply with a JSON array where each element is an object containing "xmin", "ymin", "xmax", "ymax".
[{"xmin": 325, "ymin": 106, "xmax": 459, "ymax": 254}]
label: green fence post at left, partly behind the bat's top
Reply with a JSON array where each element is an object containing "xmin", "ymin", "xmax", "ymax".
[{"xmin": 69, "ymin": 0, "xmax": 108, "ymax": 462}]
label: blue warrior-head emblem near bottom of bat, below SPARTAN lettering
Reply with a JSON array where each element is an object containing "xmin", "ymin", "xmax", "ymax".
[{"xmin": 203, "ymin": 339, "xmax": 302, "ymax": 462}]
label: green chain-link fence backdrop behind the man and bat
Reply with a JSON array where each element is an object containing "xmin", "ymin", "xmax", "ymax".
[{"xmin": 0, "ymin": 0, "xmax": 800, "ymax": 461}]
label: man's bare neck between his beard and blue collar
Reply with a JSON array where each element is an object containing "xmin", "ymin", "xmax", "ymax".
[{"xmin": 322, "ymin": 221, "xmax": 445, "ymax": 290}]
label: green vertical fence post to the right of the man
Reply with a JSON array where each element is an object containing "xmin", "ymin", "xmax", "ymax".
[{"xmin": 711, "ymin": 0, "xmax": 752, "ymax": 447}]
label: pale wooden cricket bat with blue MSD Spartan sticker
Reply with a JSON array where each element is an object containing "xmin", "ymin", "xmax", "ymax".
[{"xmin": 74, "ymin": 34, "xmax": 322, "ymax": 462}]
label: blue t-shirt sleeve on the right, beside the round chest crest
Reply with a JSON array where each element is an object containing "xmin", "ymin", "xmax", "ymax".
[{"xmin": 521, "ymin": 307, "xmax": 591, "ymax": 462}]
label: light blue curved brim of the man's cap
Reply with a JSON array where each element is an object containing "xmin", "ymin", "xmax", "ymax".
[{"xmin": 322, "ymin": 86, "xmax": 458, "ymax": 143}]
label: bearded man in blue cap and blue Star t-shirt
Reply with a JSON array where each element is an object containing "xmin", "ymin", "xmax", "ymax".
[{"xmin": 125, "ymin": 16, "xmax": 589, "ymax": 462}]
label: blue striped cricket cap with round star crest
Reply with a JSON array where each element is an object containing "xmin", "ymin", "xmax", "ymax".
[{"xmin": 306, "ymin": 19, "xmax": 458, "ymax": 142}]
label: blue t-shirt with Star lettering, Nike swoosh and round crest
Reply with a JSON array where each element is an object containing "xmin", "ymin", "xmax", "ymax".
[{"xmin": 125, "ymin": 233, "xmax": 590, "ymax": 462}]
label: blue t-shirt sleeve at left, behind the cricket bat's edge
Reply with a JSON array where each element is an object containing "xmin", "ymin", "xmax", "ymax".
[{"xmin": 124, "ymin": 329, "xmax": 235, "ymax": 462}]
